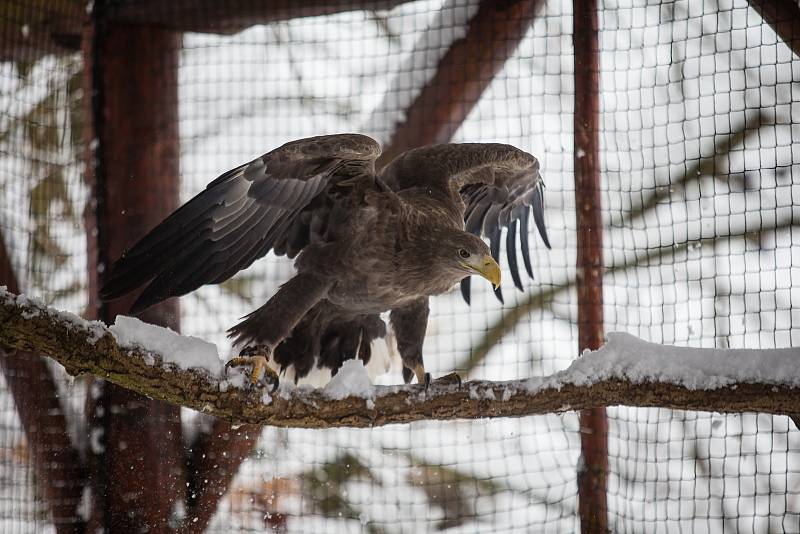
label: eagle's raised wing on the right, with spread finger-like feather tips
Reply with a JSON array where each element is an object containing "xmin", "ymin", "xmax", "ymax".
[{"xmin": 381, "ymin": 143, "xmax": 550, "ymax": 302}]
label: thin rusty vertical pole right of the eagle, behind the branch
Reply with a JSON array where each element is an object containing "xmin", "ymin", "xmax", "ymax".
[{"xmin": 572, "ymin": 0, "xmax": 608, "ymax": 534}]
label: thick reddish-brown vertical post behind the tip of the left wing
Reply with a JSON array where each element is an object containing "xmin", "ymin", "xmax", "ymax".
[{"xmin": 87, "ymin": 7, "xmax": 185, "ymax": 533}]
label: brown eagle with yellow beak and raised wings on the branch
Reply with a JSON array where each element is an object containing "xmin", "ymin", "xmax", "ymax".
[{"xmin": 101, "ymin": 134, "xmax": 550, "ymax": 387}]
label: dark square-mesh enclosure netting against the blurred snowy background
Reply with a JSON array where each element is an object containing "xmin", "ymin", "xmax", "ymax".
[{"xmin": 0, "ymin": 0, "xmax": 800, "ymax": 532}]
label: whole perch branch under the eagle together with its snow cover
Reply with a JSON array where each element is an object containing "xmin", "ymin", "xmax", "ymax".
[{"xmin": 0, "ymin": 288, "xmax": 800, "ymax": 428}]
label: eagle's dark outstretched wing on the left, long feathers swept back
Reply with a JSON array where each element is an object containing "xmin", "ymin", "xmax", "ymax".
[{"xmin": 101, "ymin": 134, "xmax": 380, "ymax": 313}]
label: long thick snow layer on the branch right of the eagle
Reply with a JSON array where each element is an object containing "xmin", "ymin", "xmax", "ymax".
[{"xmin": 528, "ymin": 332, "xmax": 800, "ymax": 398}]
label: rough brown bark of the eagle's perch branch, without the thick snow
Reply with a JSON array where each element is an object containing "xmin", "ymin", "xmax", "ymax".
[{"xmin": 0, "ymin": 292, "xmax": 800, "ymax": 428}]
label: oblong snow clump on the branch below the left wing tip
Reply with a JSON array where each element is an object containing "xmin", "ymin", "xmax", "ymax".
[{"xmin": 109, "ymin": 315, "xmax": 224, "ymax": 376}]
